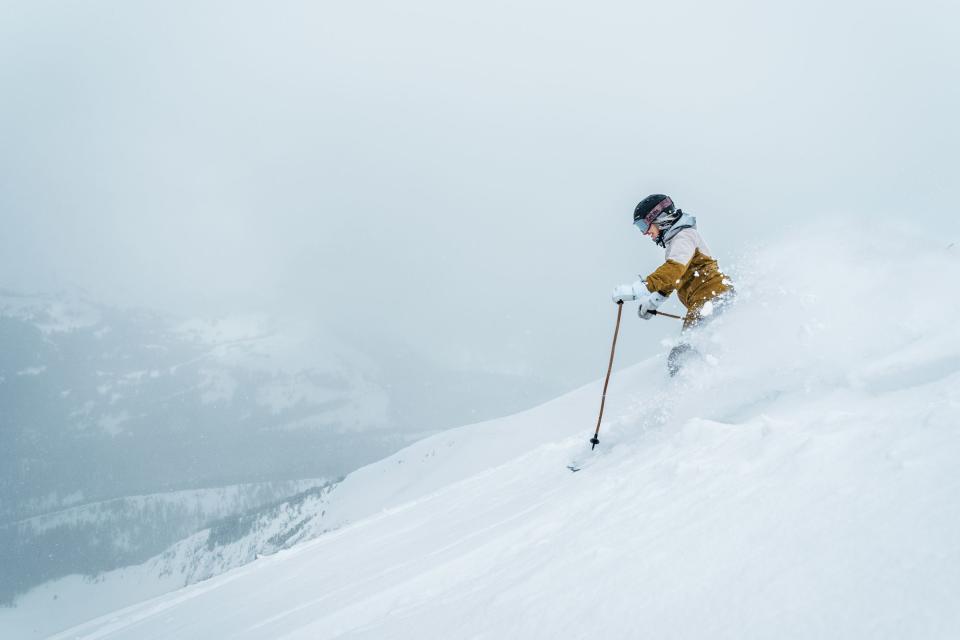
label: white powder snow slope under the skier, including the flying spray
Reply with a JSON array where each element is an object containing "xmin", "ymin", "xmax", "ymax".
[{"xmin": 16, "ymin": 228, "xmax": 960, "ymax": 640}]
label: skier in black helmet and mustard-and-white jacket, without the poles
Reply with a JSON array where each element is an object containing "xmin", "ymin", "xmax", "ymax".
[{"xmin": 613, "ymin": 193, "xmax": 734, "ymax": 376}]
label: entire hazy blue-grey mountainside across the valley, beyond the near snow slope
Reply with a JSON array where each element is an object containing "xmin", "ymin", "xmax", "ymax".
[{"xmin": 0, "ymin": 290, "xmax": 549, "ymax": 604}]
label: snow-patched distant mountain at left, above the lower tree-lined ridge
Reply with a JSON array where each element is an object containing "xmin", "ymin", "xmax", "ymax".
[{"xmin": 0, "ymin": 292, "xmax": 404, "ymax": 523}]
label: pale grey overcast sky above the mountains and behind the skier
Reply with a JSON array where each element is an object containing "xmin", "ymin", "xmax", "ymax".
[{"xmin": 0, "ymin": 0, "xmax": 960, "ymax": 396}]
